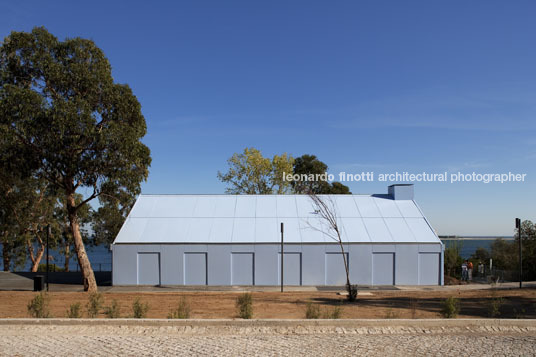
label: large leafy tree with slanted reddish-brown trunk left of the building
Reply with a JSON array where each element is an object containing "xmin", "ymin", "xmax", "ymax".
[{"xmin": 0, "ymin": 27, "xmax": 151, "ymax": 291}]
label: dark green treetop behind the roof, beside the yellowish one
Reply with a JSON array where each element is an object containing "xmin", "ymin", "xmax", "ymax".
[{"xmin": 292, "ymin": 154, "xmax": 351, "ymax": 194}]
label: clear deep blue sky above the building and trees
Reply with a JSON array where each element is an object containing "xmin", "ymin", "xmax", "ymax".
[{"xmin": 0, "ymin": 0, "xmax": 536, "ymax": 235}]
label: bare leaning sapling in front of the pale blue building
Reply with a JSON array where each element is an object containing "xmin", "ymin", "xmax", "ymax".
[{"xmin": 309, "ymin": 191, "xmax": 357, "ymax": 301}]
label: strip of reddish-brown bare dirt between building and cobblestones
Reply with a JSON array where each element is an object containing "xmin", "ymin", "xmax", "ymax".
[{"xmin": 0, "ymin": 289, "xmax": 536, "ymax": 319}]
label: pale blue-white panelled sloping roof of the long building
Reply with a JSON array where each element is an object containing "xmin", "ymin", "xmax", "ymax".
[{"xmin": 114, "ymin": 195, "xmax": 440, "ymax": 244}]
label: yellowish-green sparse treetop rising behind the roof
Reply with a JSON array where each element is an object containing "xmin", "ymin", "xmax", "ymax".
[{"xmin": 218, "ymin": 148, "xmax": 294, "ymax": 194}]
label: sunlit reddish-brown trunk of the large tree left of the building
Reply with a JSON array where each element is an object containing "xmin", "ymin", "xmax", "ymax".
[{"xmin": 67, "ymin": 192, "xmax": 97, "ymax": 293}]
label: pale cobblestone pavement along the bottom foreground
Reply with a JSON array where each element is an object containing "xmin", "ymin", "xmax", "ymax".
[{"xmin": 0, "ymin": 324, "xmax": 536, "ymax": 356}]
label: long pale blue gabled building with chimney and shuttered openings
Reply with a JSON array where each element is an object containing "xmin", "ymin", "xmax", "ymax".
[{"xmin": 112, "ymin": 185, "xmax": 443, "ymax": 285}]
